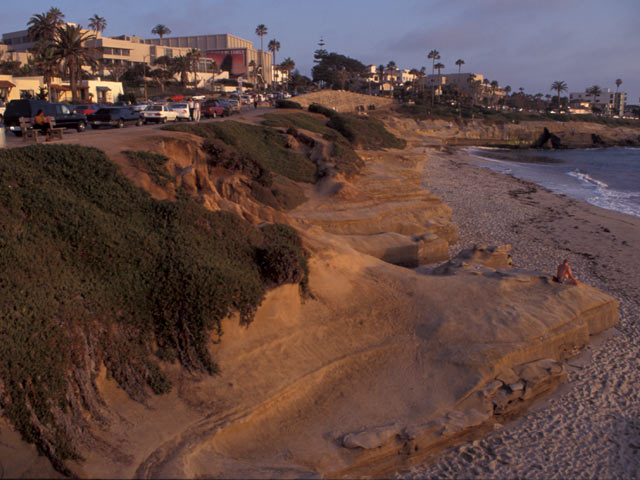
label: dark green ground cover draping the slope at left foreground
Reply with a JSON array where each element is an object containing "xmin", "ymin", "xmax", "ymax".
[{"xmin": 0, "ymin": 145, "xmax": 307, "ymax": 474}]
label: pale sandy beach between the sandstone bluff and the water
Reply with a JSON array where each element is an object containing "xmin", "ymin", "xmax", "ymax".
[{"xmin": 400, "ymin": 150, "xmax": 640, "ymax": 478}]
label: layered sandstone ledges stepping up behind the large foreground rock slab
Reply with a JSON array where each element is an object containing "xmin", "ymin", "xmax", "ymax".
[{"xmin": 291, "ymin": 150, "xmax": 457, "ymax": 267}]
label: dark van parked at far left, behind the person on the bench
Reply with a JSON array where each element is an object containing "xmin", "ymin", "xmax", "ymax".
[{"xmin": 4, "ymin": 99, "xmax": 87, "ymax": 136}]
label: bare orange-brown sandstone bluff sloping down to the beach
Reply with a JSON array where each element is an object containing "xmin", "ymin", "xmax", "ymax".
[{"xmin": 0, "ymin": 112, "xmax": 618, "ymax": 478}]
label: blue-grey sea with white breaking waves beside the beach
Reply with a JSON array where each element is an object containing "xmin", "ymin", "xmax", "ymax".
[{"xmin": 467, "ymin": 147, "xmax": 640, "ymax": 217}]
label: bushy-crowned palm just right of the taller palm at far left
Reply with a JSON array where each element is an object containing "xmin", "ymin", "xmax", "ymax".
[{"xmin": 52, "ymin": 24, "xmax": 96, "ymax": 101}]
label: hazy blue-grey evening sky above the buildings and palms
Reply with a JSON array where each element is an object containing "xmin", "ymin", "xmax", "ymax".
[{"xmin": 0, "ymin": 0, "xmax": 640, "ymax": 104}]
